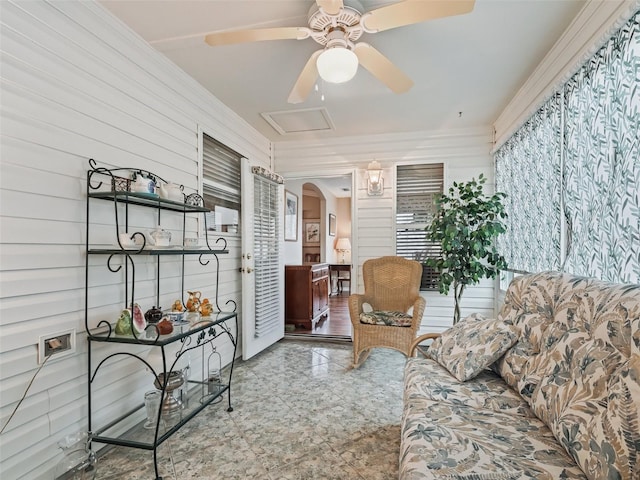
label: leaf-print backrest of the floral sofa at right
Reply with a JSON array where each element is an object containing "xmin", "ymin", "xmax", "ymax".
[{"xmin": 497, "ymin": 272, "xmax": 640, "ymax": 479}]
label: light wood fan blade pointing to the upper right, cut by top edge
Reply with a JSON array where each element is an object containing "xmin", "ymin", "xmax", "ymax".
[{"xmin": 362, "ymin": 0, "xmax": 476, "ymax": 33}]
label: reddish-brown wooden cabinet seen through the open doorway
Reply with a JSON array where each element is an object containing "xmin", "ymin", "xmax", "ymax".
[{"xmin": 284, "ymin": 263, "xmax": 329, "ymax": 329}]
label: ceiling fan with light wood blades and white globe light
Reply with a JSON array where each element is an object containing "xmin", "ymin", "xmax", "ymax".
[{"xmin": 205, "ymin": 0, "xmax": 475, "ymax": 103}]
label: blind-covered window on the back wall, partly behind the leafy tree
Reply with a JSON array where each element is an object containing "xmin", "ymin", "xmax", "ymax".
[{"xmin": 396, "ymin": 163, "xmax": 444, "ymax": 290}]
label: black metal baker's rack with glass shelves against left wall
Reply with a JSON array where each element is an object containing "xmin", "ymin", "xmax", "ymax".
[{"xmin": 85, "ymin": 159, "xmax": 238, "ymax": 480}]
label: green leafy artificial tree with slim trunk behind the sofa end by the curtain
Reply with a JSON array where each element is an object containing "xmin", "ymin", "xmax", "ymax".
[{"xmin": 425, "ymin": 174, "xmax": 507, "ymax": 325}]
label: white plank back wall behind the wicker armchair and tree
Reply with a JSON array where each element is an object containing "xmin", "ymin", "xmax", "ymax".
[{"xmin": 274, "ymin": 127, "xmax": 494, "ymax": 332}]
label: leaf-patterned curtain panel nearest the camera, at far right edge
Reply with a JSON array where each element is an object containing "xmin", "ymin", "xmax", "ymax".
[{"xmin": 564, "ymin": 12, "xmax": 640, "ymax": 283}]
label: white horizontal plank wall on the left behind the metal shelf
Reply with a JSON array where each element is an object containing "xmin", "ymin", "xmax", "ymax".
[{"xmin": 0, "ymin": 1, "xmax": 271, "ymax": 480}]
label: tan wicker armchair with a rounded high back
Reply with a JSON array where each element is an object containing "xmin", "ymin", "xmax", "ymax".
[{"xmin": 349, "ymin": 256, "xmax": 426, "ymax": 368}]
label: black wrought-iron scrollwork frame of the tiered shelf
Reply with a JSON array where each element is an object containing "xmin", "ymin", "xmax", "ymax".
[{"xmin": 85, "ymin": 159, "xmax": 238, "ymax": 478}]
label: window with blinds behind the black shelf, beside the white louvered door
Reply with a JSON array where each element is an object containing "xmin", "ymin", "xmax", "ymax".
[{"xmin": 202, "ymin": 134, "xmax": 242, "ymax": 232}]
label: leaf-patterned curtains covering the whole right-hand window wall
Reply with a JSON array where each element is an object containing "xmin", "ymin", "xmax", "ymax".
[{"xmin": 495, "ymin": 11, "xmax": 640, "ymax": 283}]
